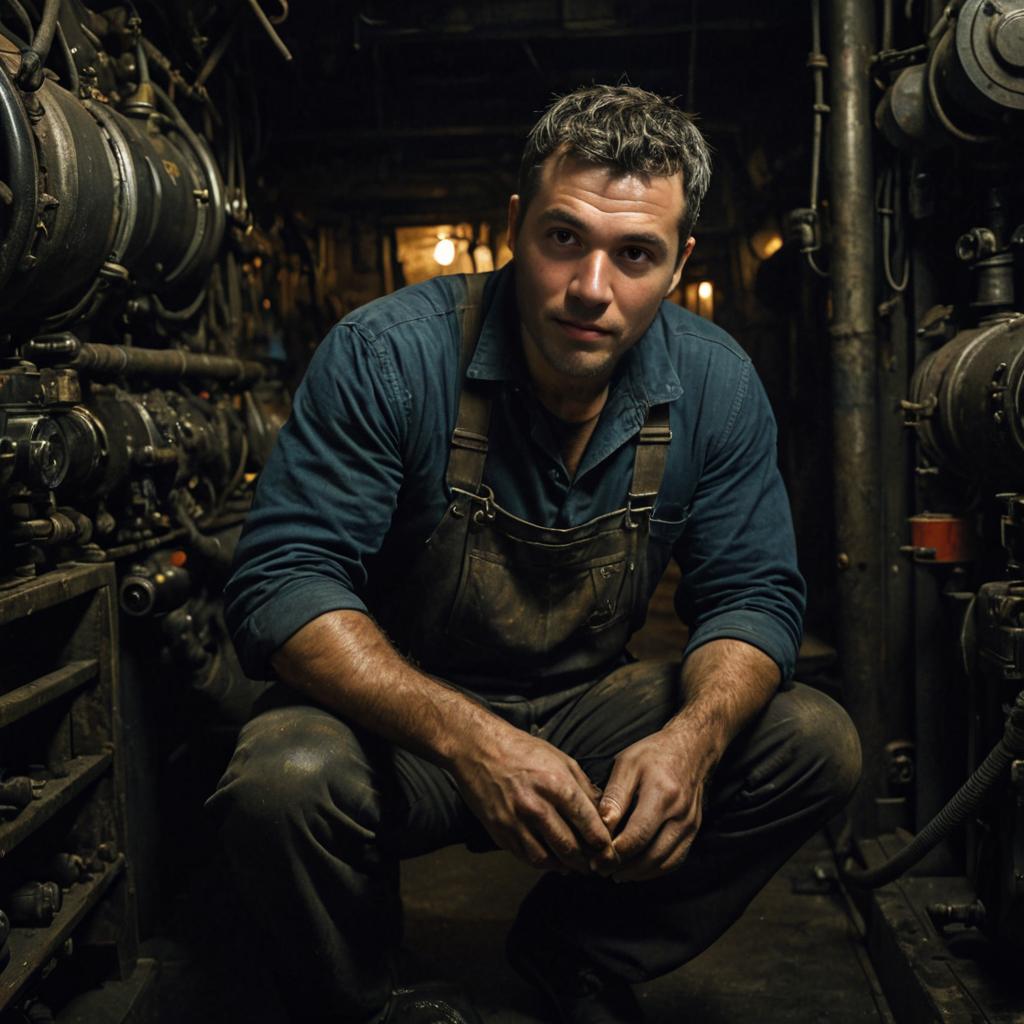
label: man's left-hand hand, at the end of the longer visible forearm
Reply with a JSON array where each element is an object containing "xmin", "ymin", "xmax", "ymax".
[{"xmin": 452, "ymin": 724, "xmax": 617, "ymax": 873}]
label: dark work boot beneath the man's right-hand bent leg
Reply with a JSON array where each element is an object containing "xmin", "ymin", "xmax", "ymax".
[{"xmin": 505, "ymin": 924, "xmax": 643, "ymax": 1024}]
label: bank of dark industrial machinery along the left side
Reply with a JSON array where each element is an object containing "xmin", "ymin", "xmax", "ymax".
[{"xmin": 0, "ymin": 0, "xmax": 296, "ymax": 1021}]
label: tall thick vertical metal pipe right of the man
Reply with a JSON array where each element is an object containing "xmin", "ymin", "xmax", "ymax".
[{"xmin": 828, "ymin": 0, "xmax": 886, "ymax": 834}]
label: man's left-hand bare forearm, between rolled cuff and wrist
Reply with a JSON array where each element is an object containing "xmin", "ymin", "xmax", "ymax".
[{"xmin": 271, "ymin": 610, "xmax": 499, "ymax": 767}]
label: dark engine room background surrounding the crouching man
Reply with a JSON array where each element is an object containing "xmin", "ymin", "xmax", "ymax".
[{"xmin": 0, "ymin": 0, "xmax": 1024, "ymax": 1024}]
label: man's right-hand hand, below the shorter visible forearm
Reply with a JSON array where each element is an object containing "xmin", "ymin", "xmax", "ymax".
[{"xmin": 594, "ymin": 731, "xmax": 714, "ymax": 882}]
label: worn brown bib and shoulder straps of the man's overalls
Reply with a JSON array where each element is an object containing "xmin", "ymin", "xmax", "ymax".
[{"xmin": 379, "ymin": 274, "xmax": 672, "ymax": 692}]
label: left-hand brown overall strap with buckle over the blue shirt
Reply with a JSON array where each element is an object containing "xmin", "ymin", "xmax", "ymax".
[{"xmin": 446, "ymin": 273, "xmax": 490, "ymax": 494}]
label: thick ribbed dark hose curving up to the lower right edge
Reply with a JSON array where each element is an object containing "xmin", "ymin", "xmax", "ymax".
[{"xmin": 842, "ymin": 690, "xmax": 1024, "ymax": 889}]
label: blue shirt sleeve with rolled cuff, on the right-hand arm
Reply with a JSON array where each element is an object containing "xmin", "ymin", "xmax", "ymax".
[{"xmin": 674, "ymin": 360, "xmax": 805, "ymax": 681}]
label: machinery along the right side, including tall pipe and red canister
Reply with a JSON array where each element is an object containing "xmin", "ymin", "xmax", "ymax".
[{"xmin": 811, "ymin": 0, "xmax": 1024, "ymax": 1021}]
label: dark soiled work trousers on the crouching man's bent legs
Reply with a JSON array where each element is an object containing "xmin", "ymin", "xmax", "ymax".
[{"xmin": 203, "ymin": 662, "xmax": 860, "ymax": 1024}]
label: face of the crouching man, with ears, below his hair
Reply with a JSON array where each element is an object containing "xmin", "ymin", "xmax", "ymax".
[{"xmin": 509, "ymin": 153, "xmax": 693, "ymax": 384}]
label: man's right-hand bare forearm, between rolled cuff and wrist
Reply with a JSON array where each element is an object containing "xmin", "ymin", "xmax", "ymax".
[{"xmin": 664, "ymin": 639, "xmax": 779, "ymax": 771}]
